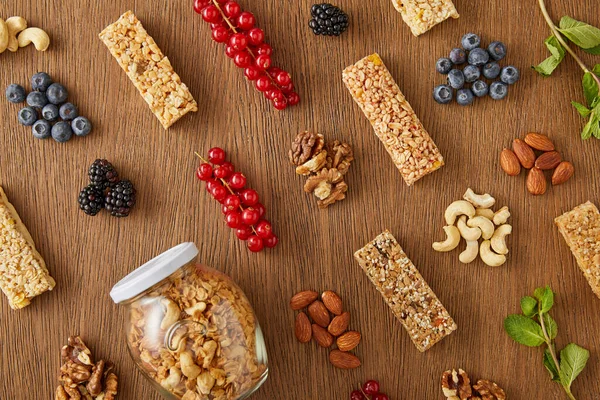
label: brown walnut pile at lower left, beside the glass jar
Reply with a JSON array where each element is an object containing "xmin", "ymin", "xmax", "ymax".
[{"xmin": 55, "ymin": 336, "xmax": 118, "ymax": 400}]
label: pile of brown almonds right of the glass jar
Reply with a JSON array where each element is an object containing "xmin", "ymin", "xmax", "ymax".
[{"xmin": 290, "ymin": 290, "xmax": 361, "ymax": 369}]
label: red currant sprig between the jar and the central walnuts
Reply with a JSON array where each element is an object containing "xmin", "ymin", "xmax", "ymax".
[{"xmin": 195, "ymin": 147, "xmax": 279, "ymax": 252}]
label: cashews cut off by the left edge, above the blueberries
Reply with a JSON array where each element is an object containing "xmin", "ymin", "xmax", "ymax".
[{"xmin": 0, "ymin": 17, "xmax": 50, "ymax": 53}]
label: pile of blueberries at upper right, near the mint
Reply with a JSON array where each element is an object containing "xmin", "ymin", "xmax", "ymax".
[{"xmin": 433, "ymin": 33, "xmax": 520, "ymax": 106}]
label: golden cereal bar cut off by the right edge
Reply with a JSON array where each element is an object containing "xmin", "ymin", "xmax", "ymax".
[{"xmin": 554, "ymin": 201, "xmax": 600, "ymax": 298}]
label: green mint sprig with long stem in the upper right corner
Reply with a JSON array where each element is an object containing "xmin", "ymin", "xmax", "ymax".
[{"xmin": 533, "ymin": 0, "xmax": 600, "ymax": 140}]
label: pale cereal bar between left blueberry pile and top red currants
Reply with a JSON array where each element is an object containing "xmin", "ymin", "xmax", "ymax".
[{"xmin": 99, "ymin": 11, "xmax": 198, "ymax": 129}]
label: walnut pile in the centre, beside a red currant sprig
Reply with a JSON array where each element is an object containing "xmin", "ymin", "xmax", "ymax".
[{"xmin": 289, "ymin": 132, "xmax": 354, "ymax": 208}]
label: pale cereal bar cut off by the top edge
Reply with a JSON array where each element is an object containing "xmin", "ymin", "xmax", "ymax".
[{"xmin": 392, "ymin": 0, "xmax": 459, "ymax": 36}]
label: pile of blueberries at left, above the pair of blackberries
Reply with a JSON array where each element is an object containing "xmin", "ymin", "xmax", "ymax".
[{"xmin": 6, "ymin": 72, "xmax": 92, "ymax": 143}]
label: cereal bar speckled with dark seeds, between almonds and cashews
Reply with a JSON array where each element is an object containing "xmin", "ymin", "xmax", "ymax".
[{"xmin": 354, "ymin": 230, "xmax": 456, "ymax": 352}]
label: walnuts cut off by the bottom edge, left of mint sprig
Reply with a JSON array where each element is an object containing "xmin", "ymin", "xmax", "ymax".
[{"xmin": 442, "ymin": 368, "xmax": 506, "ymax": 400}]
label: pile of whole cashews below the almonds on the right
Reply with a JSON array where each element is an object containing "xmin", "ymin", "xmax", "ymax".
[{"xmin": 433, "ymin": 188, "xmax": 512, "ymax": 267}]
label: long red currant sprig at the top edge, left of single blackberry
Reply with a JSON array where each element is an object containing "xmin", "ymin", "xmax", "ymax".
[{"xmin": 194, "ymin": 0, "xmax": 300, "ymax": 110}]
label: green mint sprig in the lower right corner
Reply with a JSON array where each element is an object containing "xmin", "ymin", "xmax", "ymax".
[{"xmin": 504, "ymin": 286, "xmax": 590, "ymax": 400}]
